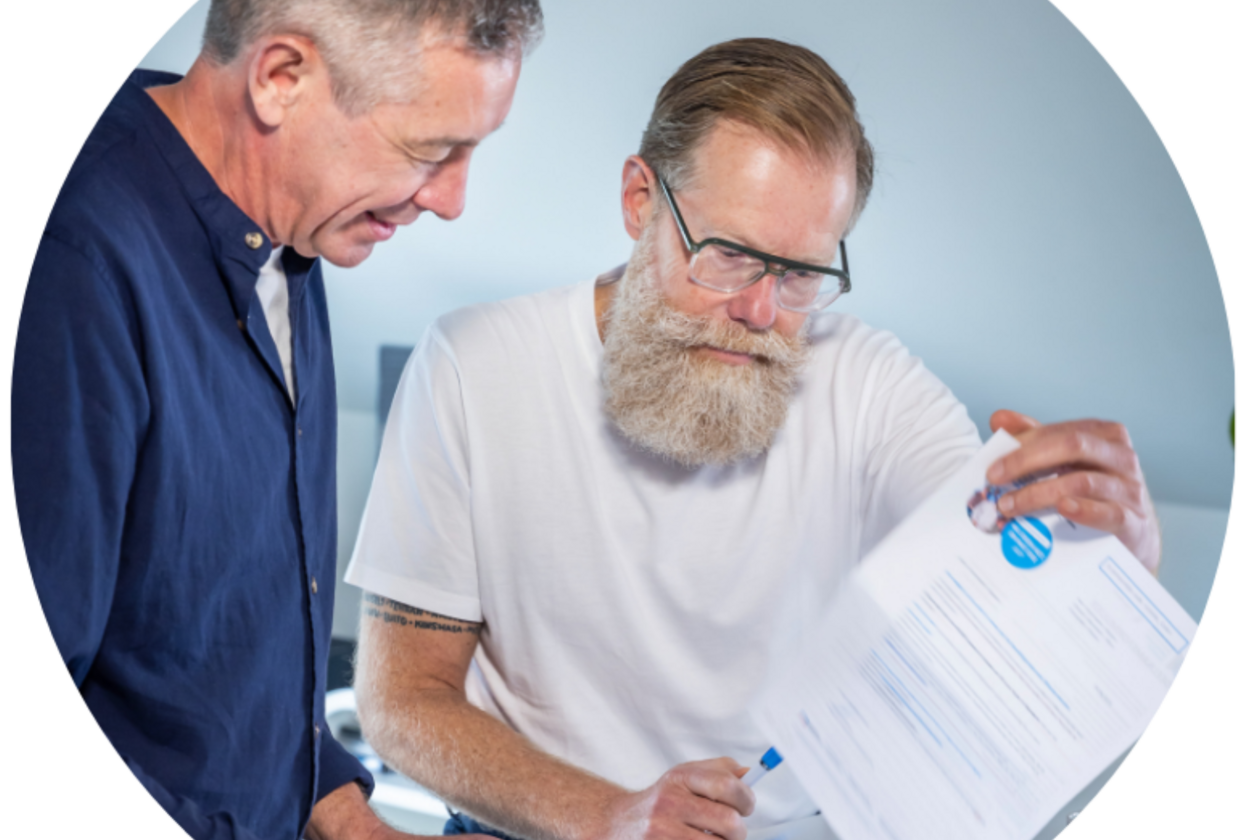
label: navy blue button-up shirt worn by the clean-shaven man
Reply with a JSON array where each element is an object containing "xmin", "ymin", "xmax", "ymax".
[{"xmin": 9, "ymin": 71, "xmax": 371, "ymax": 840}]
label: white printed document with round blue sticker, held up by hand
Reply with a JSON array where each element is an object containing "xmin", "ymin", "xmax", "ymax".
[{"xmin": 751, "ymin": 432, "xmax": 1199, "ymax": 840}]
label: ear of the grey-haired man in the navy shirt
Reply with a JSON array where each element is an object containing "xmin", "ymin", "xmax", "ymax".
[{"xmin": 247, "ymin": 35, "xmax": 331, "ymax": 128}]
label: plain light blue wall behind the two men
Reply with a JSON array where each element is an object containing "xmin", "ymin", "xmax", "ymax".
[{"xmin": 140, "ymin": 0, "xmax": 1237, "ymax": 508}]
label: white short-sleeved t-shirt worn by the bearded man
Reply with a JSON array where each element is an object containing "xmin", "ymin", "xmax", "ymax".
[{"xmin": 346, "ymin": 276, "xmax": 981, "ymax": 828}]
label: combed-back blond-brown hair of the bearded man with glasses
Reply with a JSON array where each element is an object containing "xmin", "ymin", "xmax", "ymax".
[{"xmin": 639, "ymin": 37, "xmax": 873, "ymax": 222}]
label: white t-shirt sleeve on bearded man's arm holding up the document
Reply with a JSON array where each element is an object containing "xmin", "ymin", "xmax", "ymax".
[{"xmin": 858, "ymin": 324, "xmax": 982, "ymax": 556}]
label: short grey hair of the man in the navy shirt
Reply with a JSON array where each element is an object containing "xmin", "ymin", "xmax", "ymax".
[{"xmin": 203, "ymin": 0, "xmax": 543, "ymax": 116}]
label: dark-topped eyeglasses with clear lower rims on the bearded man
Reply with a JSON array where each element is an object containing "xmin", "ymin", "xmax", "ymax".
[{"xmin": 658, "ymin": 176, "xmax": 852, "ymax": 312}]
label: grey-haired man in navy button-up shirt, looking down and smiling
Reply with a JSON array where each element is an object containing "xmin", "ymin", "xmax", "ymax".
[{"xmin": 9, "ymin": 0, "xmax": 541, "ymax": 839}]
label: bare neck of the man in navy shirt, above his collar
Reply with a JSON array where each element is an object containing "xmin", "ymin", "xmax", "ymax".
[{"xmin": 147, "ymin": 55, "xmax": 279, "ymax": 246}]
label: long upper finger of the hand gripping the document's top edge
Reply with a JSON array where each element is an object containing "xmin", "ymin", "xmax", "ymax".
[{"xmin": 987, "ymin": 420, "xmax": 1140, "ymax": 485}]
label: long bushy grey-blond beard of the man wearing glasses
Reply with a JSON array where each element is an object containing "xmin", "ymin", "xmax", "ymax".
[{"xmin": 603, "ymin": 226, "xmax": 810, "ymax": 467}]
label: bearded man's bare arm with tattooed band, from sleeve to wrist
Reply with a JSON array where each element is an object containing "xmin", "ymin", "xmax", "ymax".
[{"xmin": 355, "ymin": 593, "xmax": 627, "ymax": 840}]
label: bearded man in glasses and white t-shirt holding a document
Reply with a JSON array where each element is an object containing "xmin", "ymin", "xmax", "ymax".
[{"xmin": 346, "ymin": 39, "xmax": 1159, "ymax": 840}]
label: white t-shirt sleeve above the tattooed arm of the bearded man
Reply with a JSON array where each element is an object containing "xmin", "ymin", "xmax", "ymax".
[{"xmin": 345, "ymin": 324, "xmax": 481, "ymax": 621}]
